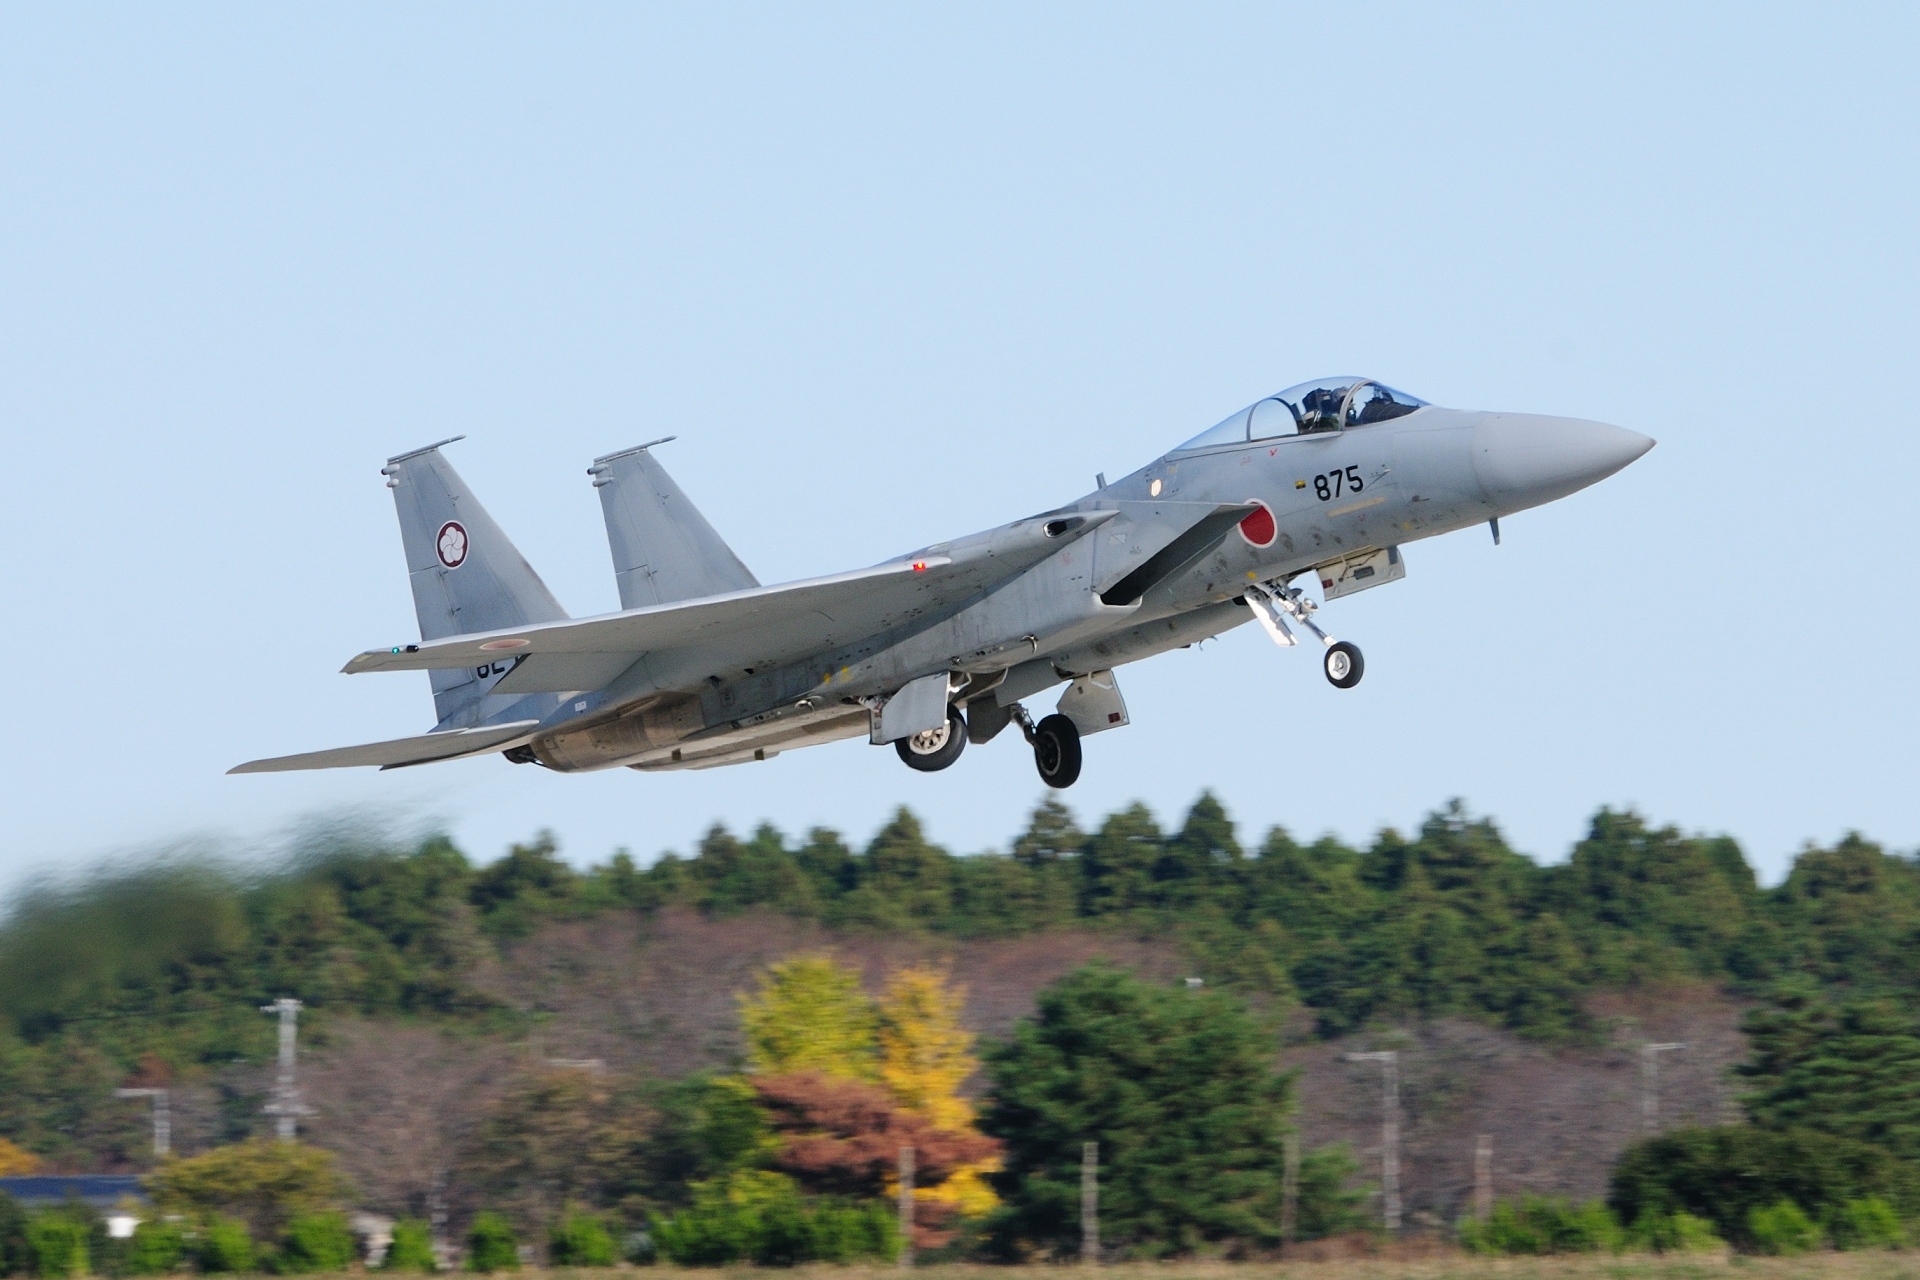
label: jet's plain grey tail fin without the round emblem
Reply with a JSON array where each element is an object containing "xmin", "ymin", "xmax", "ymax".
[{"xmin": 588, "ymin": 436, "xmax": 760, "ymax": 608}]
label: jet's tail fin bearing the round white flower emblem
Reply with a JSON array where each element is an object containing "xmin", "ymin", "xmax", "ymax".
[{"xmin": 380, "ymin": 436, "xmax": 566, "ymax": 727}]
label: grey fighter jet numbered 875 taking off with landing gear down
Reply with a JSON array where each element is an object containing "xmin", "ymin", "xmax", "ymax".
[{"xmin": 232, "ymin": 378, "xmax": 1653, "ymax": 787}]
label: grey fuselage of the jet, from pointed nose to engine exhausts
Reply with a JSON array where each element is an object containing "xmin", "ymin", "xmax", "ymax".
[{"xmin": 534, "ymin": 405, "xmax": 1651, "ymax": 770}]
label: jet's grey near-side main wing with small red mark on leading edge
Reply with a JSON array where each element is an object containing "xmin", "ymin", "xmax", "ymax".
[{"xmin": 344, "ymin": 512, "xmax": 1112, "ymax": 693}]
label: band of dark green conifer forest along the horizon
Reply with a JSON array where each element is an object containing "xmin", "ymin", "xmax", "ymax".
[{"xmin": 0, "ymin": 794, "xmax": 1920, "ymax": 1163}]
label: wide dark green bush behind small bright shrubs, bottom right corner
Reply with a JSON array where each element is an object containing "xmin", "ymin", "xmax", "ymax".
[{"xmin": 1607, "ymin": 1125, "xmax": 1920, "ymax": 1249}]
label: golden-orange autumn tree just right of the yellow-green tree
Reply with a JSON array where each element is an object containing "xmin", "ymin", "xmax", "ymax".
[{"xmin": 879, "ymin": 967, "xmax": 1000, "ymax": 1217}]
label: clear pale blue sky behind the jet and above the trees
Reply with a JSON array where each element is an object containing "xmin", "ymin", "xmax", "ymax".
[{"xmin": 0, "ymin": 4, "xmax": 1920, "ymax": 885}]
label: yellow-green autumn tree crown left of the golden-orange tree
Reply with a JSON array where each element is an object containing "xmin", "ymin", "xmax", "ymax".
[{"xmin": 739, "ymin": 952, "xmax": 879, "ymax": 1080}]
